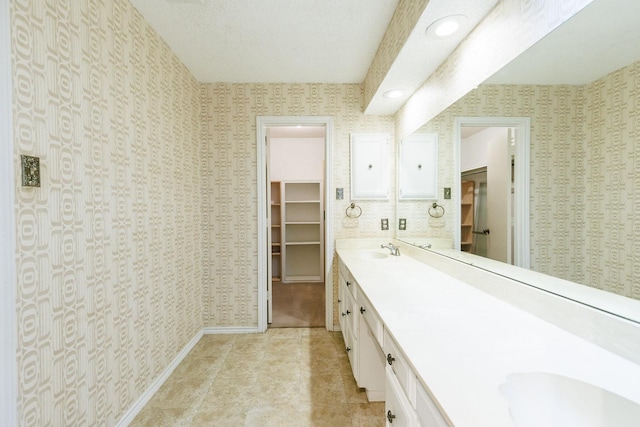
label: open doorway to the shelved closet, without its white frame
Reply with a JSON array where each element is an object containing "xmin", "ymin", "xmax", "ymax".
[{"xmin": 266, "ymin": 125, "xmax": 326, "ymax": 328}]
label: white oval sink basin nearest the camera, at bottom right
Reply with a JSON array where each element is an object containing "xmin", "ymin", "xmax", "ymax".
[{"xmin": 500, "ymin": 372, "xmax": 640, "ymax": 427}]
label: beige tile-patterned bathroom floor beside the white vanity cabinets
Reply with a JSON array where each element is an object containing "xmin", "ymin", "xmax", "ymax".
[{"xmin": 131, "ymin": 328, "xmax": 385, "ymax": 427}]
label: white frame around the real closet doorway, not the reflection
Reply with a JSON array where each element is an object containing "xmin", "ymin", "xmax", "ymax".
[{"xmin": 256, "ymin": 116, "xmax": 333, "ymax": 332}]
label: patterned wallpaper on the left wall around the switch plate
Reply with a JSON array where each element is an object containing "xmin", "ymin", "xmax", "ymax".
[{"xmin": 11, "ymin": 0, "xmax": 203, "ymax": 426}]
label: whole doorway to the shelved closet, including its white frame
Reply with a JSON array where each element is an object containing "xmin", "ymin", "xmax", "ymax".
[{"xmin": 256, "ymin": 116, "xmax": 333, "ymax": 332}]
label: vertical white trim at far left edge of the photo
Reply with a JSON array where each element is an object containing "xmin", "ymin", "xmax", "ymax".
[{"xmin": 0, "ymin": 0, "xmax": 18, "ymax": 426}]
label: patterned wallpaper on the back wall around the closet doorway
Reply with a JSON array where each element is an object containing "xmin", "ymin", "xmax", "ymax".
[{"xmin": 202, "ymin": 83, "xmax": 395, "ymax": 327}]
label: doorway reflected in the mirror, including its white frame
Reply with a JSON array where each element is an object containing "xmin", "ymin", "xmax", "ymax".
[{"xmin": 454, "ymin": 117, "xmax": 530, "ymax": 268}]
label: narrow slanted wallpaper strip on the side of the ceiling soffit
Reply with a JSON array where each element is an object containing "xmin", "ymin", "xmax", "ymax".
[{"xmin": 363, "ymin": 0, "xmax": 429, "ymax": 106}]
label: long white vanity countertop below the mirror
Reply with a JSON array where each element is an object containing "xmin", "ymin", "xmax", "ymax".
[{"xmin": 337, "ymin": 245, "xmax": 640, "ymax": 427}]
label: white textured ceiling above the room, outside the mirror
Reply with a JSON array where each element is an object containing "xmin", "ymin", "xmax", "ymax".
[{"xmin": 131, "ymin": 0, "xmax": 398, "ymax": 83}]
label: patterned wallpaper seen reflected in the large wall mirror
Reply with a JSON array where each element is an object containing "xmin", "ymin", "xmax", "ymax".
[{"xmin": 416, "ymin": 62, "xmax": 640, "ymax": 299}]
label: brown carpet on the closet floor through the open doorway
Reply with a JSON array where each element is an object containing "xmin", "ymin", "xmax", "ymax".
[{"xmin": 269, "ymin": 282, "xmax": 325, "ymax": 328}]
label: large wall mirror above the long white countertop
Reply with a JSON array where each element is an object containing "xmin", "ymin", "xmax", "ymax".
[{"xmin": 397, "ymin": 0, "xmax": 640, "ymax": 322}]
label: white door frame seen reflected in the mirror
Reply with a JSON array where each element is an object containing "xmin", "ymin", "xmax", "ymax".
[{"xmin": 453, "ymin": 117, "xmax": 531, "ymax": 269}]
